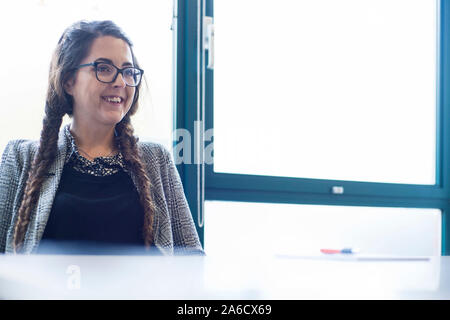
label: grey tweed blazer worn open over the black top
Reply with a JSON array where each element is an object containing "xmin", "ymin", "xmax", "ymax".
[{"xmin": 0, "ymin": 128, "xmax": 203, "ymax": 255}]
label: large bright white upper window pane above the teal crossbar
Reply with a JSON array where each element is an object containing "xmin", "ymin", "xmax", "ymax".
[{"xmin": 214, "ymin": 0, "xmax": 437, "ymax": 185}]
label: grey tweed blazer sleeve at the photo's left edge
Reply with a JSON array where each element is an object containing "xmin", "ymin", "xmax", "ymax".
[{"xmin": 0, "ymin": 140, "xmax": 21, "ymax": 253}]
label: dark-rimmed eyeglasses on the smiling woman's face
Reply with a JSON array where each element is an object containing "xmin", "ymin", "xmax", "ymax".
[{"xmin": 75, "ymin": 61, "xmax": 144, "ymax": 87}]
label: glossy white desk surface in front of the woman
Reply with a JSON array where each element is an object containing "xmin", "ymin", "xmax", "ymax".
[{"xmin": 0, "ymin": 255, "xmax": 450, "ymax": 300}]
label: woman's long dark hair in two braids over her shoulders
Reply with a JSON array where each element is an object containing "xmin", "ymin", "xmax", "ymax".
[{"xmin": 13, "ymin": 21, "xmax": 155, "ymax": 252}]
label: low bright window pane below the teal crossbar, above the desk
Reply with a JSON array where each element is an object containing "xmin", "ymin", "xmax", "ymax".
[{"xmin": 205, "ymin": 201, "xmax": 442, "ymax": 256}]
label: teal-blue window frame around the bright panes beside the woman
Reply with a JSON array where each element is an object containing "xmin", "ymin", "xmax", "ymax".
[{"xmin": 174, "ymin": 0, "xmax": 450, "ymax": 255}]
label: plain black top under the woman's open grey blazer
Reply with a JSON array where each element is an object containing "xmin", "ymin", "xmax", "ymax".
[{"xmin": 42, "ymin": 164, "xmax": 144, "ymax": 246}]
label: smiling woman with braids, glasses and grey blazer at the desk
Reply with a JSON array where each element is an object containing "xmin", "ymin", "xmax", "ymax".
[{"xmin": 0, "ymin": 21, "xmax": 203, "ymax": 254}]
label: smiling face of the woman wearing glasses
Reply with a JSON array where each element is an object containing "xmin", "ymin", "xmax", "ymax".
[{"xmin": 65, "ymin": 36, "xmax": 136, "ymax": 126}]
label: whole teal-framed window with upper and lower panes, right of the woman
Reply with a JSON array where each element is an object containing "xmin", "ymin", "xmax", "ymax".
[{"xmin": 177, "ymin": 0, "xmax": 450, "ymax": 255}]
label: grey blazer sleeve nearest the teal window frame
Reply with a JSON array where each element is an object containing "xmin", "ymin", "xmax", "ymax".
[{"xmin": 161, "ymin": 146, "xmax": 204, "ymax": 255}]
